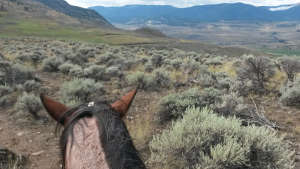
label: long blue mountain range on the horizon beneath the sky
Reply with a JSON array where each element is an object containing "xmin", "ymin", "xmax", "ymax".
[{"xmin": 90, "ymin": 3, "xmax": 300, "ymax": 25}]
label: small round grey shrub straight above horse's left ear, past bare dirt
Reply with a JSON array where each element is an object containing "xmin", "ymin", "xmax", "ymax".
[{"xmin": 42, "ymin": 57, "xmax": 64, "ymax": 72}]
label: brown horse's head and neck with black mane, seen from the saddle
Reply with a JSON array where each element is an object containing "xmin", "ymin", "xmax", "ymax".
[{"xmin": 41, "ymin": 90, "xmax": 146, "ymax": 169}]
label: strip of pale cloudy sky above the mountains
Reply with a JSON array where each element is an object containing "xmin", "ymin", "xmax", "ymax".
[{"xmin": 66, "ymin": 0, "xmax": 300, "ymax": 8}]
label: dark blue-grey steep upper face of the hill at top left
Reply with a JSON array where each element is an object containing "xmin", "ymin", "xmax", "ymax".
[{"xmin": 35, "ymin": 0, "xmax": 111, "ymax": 26}]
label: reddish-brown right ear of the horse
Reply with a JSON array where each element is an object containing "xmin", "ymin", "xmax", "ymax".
[{"xmin": 111, "ymin": 89, "xmax": 137, "ymax": 117}]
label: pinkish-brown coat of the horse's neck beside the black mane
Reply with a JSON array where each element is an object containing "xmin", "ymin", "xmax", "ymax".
[{"xmin": 65, "ymin": 118, "xmax": 109, "ymax": 169}]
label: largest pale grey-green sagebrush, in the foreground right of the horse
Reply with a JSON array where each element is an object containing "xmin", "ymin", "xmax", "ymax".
[{"xmin": 149, "ymin": 107, "xmax": 295, "ymax": 169}]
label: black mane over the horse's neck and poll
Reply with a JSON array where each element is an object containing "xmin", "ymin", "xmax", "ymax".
[{"xmin": 60, "ymin": 102, "xmax": 146, "ymax": 169}]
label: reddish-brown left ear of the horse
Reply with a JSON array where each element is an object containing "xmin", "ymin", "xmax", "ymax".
[{"xmin": 40, "ymin": 94, "xmax": 68, "ymax": 122}]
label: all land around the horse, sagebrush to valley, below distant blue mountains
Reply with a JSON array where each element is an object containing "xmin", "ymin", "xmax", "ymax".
[{"xmin": 0, "ymin": 0, "xmax": 300, "ymax": 169}]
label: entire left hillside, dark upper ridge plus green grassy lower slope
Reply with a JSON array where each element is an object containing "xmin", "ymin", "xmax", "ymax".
[{"xmin": 0, "ymin": 0, "xmax": 169, "ymax": 44}]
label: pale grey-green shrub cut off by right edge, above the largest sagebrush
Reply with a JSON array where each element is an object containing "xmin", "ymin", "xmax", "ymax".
[{"xmin": 280, "ymin": 78, "xmax": 300, "ymax": 107}]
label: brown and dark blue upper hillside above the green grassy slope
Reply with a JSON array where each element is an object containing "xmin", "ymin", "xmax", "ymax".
[{"xmin": 0, "ymin": 0, "xmax": 112, "ymax": 27}]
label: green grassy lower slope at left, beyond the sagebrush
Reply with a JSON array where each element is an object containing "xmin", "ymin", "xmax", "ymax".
[{"xmin": 0, "ymin": 12, "xmax": 160, "ymax": 45}]
